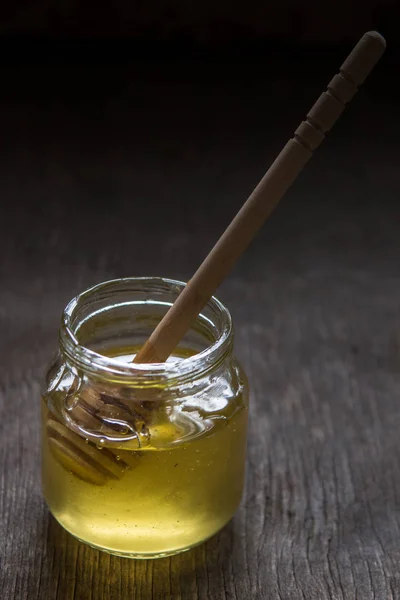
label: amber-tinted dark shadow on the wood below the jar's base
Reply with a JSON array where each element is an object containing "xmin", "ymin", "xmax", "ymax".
[{"xmin": 39, "ymin": 513, "xmax": 240, "ymax": 600}]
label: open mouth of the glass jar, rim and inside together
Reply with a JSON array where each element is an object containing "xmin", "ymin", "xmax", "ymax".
[{"xmin": 60, "ymin": 277, "xmax": 233, "ymax": 383}]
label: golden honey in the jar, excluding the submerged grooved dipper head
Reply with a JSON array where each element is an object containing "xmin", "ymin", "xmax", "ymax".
[{"xmin": 42, "ymin": 346, "xmax": 247, "ymax": 557}]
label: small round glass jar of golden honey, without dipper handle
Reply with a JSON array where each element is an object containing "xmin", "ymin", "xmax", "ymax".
[{"xmin": 42, "ymin": 278, "xmax": 248, "ymax": 558}]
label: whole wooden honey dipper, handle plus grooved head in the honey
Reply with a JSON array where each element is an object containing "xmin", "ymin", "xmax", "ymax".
[{"xmin": 47, "ymin": 31, "xmax": 386, "ymax": 483}]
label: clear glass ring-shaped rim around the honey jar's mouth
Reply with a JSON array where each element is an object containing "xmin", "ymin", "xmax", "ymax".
[{"xmin": 60, "ymin": 277, "xmax": 233, "ymax": 383}]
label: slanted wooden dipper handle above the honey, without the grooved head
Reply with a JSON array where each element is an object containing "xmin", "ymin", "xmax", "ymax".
[{"xmin": 134, "ymin": 31, "xmax": 386, "ymax": 363}]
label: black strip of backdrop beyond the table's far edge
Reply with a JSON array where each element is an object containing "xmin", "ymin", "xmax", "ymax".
[{"xmin": 0, "ymin": 0, "xmax": 399, "ymax": 45}]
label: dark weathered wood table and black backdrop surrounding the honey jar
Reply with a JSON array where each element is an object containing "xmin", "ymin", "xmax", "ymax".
[{"xmin": 0, "ymin": 0, "xmax": 400, "ymax": 600}]
